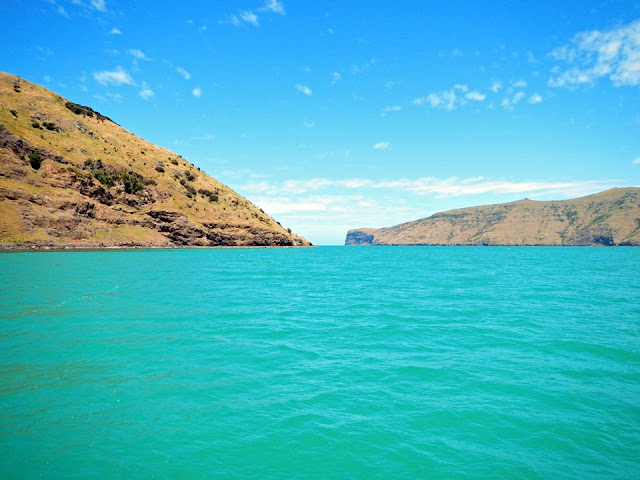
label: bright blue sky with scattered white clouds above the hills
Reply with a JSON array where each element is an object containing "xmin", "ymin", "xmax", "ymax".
[{"xmin": 0, "ymin": 0, "xmax": 640, "ymax": 245}]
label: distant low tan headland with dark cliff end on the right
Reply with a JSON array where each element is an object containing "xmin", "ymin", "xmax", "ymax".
[{"xmin": 345, "ymin": 188, "xmax": 640, "ymax": 246}]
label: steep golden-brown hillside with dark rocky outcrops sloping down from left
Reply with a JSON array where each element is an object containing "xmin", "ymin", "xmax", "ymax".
[{"xmin": 0, "ymin": 73, "xmax": 310, "ymax": 248}]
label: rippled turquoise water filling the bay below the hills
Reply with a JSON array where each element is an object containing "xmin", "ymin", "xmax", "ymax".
[{"xmin": 0, "ymin": 247, "xmax": 640, "ymax": 480}]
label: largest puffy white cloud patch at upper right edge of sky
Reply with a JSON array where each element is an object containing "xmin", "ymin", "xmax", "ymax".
[{"xmin": 548, "ymin": 20, "xmax": 640, "ymax": 87}]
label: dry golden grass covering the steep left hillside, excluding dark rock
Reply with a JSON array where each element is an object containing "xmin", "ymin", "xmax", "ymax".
[{"xmin": 0, "ymin": 73, "xmax": 308, "ymax": 245}]
